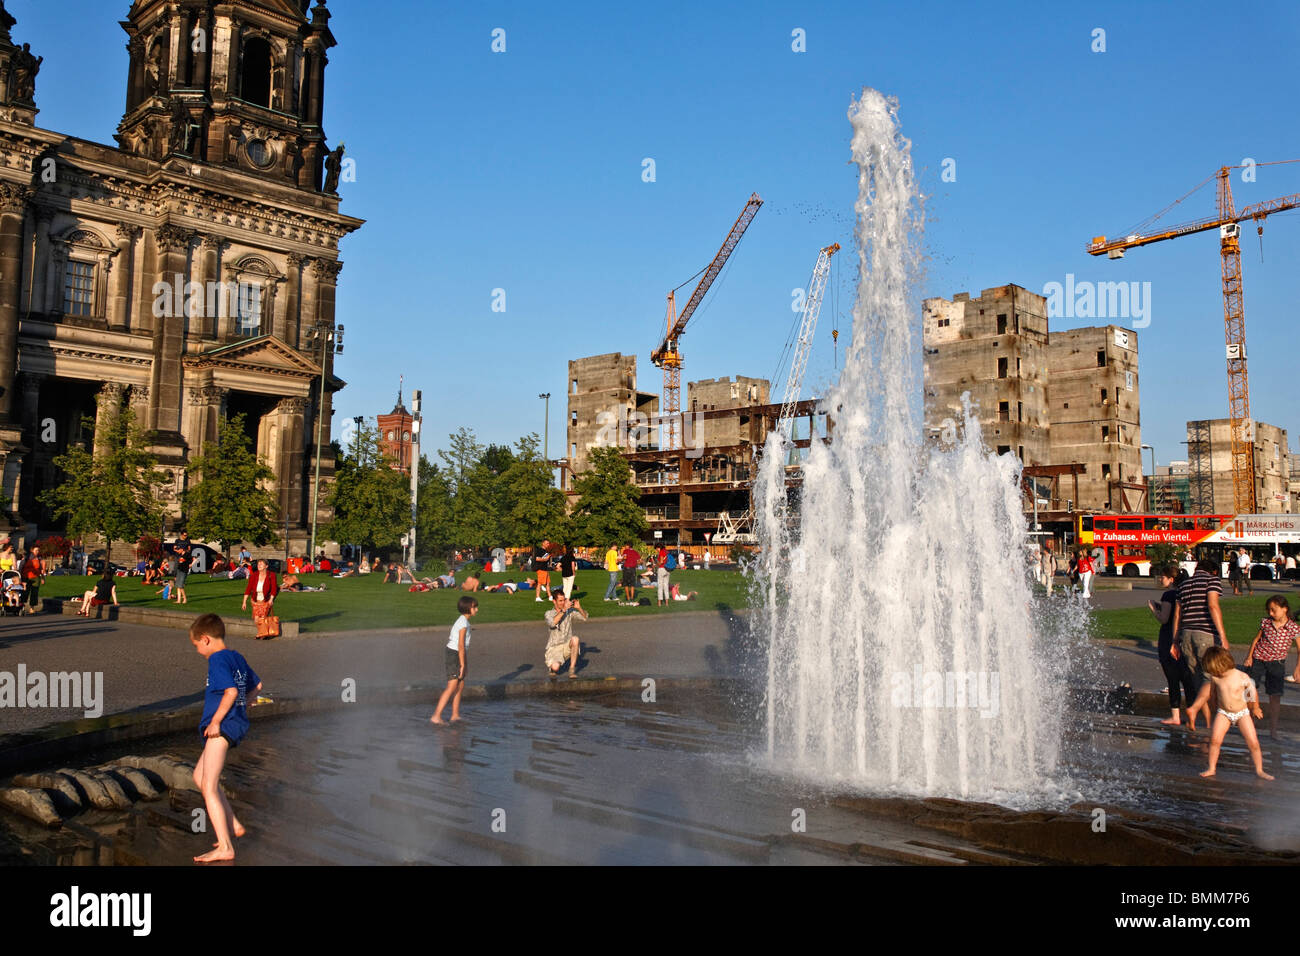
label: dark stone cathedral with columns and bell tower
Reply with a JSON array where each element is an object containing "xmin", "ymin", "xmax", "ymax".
[{"xmin": 0, "ymin": 0, "xmax": 361, "ymax": 550}]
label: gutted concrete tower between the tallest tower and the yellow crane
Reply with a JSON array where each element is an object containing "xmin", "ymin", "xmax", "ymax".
[{"xmin": 1048, "ymin": 325, "xmax": 1149, "ymax": 512}]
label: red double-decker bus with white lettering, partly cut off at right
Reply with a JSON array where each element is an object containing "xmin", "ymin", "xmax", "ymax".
[{"xmin": 1074, "ymin": 514, "xmax": 1300, "ymax": 576}]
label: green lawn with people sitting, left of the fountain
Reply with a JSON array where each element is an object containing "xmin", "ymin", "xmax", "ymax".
[{"xmin": 40, "ymin": 571, "xmax": 748, "ymax": 631}]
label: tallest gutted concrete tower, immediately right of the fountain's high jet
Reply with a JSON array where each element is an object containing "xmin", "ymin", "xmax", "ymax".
[{"xmin": 922, "ymin": 285, "xmax": 1050, "ymax": 464}]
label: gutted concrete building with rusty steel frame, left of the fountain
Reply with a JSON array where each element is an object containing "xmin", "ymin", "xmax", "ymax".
[{"xmin": 560, "ymin": 352, "xmax": 827, "ymax": 545}]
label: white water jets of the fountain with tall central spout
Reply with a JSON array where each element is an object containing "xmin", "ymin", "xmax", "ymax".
[{"xmin": 755, "ymin": 90, "xmax": 1083, "ymax": 803}]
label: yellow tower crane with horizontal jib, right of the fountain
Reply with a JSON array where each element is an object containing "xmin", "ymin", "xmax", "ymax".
[{"xmin": 1087, "ymin": 160, "xmax": 1300, "ymax": 514}]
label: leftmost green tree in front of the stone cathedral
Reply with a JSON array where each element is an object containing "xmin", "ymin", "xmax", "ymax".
[{"xmin": 40, "ymin": 408, "xmax": 172, "ymax": 553}]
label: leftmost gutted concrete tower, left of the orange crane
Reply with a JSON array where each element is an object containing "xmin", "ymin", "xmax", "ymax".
[{"xmin": 560, "ymin": 352, "xmax": 659, "ymax": 492}]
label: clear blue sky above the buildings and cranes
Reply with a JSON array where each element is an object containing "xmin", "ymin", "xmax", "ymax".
[{"xmin": 8, "ymin": 0, "xmax": 1300, "ymax": 462}]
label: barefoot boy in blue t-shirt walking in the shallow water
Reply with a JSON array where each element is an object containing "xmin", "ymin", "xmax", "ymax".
[{"xmin": 190, "ymin": 614, "xmax": 261, "ymax": 864}]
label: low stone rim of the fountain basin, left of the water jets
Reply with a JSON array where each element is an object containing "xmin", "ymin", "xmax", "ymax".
[{"xmin": 0, "ymin": 675, "xmax": 737, "ymax": 775}]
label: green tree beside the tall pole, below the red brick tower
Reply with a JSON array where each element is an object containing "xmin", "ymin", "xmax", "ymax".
[{"xmin": 325, "ymin": 423, "xmax": 411, "ymax": 548}]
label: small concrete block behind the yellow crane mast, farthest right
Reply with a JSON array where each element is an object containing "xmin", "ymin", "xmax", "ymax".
[{"xmin": 1187, "ymin": 419, "xmax": 1292, "ymax": 515}]
